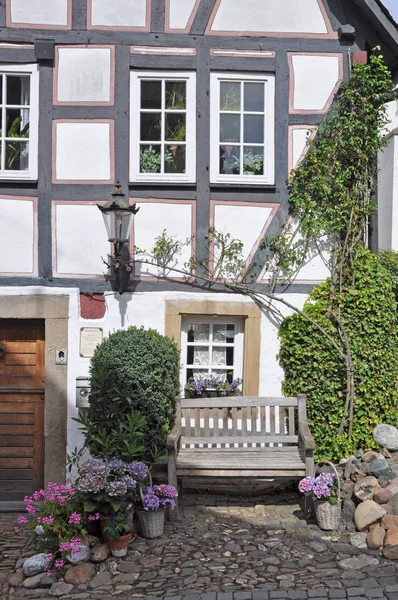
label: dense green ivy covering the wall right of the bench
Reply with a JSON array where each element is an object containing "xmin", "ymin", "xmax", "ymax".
[{"xmin": 279, "ymin": 249, "xmax": 398, "ymax": 459}]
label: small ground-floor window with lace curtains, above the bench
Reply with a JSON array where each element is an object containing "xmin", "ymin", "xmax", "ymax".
[{"xmin": 181, "ymin": 316, "xmax": 244, "ymax": 396}]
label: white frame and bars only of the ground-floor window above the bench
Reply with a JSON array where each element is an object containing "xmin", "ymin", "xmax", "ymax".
[{"xmin": 180, "ymin": 315, "xmax": 244, "ymax": 390}]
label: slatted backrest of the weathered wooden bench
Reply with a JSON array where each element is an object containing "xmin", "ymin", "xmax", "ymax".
[{"xmin": 180, "ymin": 395, "xmax": 307, "ymax": 448}]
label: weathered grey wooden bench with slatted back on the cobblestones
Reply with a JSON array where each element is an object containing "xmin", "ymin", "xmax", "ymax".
[{"xmin": 167, "ymin": 394, "xmax": 315, "ymax": 510}]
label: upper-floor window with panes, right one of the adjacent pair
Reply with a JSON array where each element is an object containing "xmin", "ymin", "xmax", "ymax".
[{"xmin": 210, "ymin": 73, "xmax": 275, "ymax": 184}]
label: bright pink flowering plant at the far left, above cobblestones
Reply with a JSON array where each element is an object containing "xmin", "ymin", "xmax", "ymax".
[{"xmin": 14, "ymin": 480, "xmax": 95, "ymax": 568}]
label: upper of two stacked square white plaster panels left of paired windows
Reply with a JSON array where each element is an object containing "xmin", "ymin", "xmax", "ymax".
[{"xmin": 57, "ymin": 48, "xmax": 111, "ymax": 102}]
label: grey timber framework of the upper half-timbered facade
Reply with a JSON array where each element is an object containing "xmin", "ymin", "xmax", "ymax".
[{"xmin": 0, "ymin": 0, "xmax": 398, "ymax": 293}]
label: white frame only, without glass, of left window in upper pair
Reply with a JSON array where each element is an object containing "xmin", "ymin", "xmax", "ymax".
[{"xmin": 130, "ymin": 71, "xmax": 196, "ymax": 183}]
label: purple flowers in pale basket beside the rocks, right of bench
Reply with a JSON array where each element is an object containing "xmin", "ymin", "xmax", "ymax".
[{"xmin": 298, "ymin": 467, "xmax": 341, "ymax": 530}]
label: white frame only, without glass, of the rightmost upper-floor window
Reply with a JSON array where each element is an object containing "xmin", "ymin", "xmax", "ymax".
[{"xmin": 210, "ymin": 72, "xmax": 275, "ymax": 185}]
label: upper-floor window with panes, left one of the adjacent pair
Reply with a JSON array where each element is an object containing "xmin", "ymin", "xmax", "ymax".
[{"xmin": 130, "ymin": 71, "xmax": 196, "ymax": 182}]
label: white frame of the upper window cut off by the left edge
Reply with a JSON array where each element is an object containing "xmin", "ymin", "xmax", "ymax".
[{"xmin": 0, "ymin": 64, "xmax": 39, "ymax": 181}]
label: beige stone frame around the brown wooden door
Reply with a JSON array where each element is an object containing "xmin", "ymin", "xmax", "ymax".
[{"xmin": 0, "ymin": 294, "xmax": 69, "ymax": 485}]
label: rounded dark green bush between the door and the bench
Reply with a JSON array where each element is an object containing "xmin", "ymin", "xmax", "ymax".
[{"xmin": 87, "ymin": 327, "xmax": 180, "ymax": 460}]
